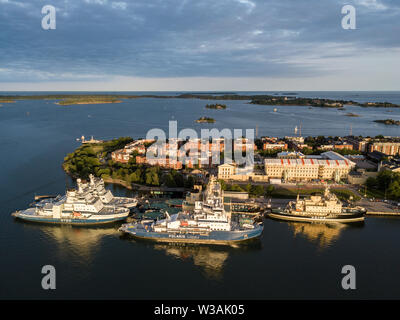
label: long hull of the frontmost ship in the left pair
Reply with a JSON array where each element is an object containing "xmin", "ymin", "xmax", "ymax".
[{"xmin": 12, "ymin": 212, "xmax": 127, "ymax": 226}]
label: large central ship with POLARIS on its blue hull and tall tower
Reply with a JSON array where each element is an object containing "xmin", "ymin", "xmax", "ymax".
[{"xmin": 119, "ymin": 176, "xmax": 264, "ymax": 246}]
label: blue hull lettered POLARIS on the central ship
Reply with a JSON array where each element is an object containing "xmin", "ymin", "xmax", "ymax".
[{"xmin": 120, "ymin": 225, "xmax": 263, "ymax": 245}]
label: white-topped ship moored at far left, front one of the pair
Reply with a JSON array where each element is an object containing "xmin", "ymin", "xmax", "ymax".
[{"xmin": 12, "ymin": 179, "xmax": 130, "ymax": 225}]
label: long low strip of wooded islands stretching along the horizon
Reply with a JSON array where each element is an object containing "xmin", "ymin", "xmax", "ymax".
[{"xmin": 0, "ymin": 93, "xmax": 400, "ymax": 109}]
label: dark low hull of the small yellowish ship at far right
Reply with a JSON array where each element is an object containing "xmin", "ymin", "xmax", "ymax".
[{"xmin": 267, "ymin": 211, "xmax": 364, "ymax": 223}]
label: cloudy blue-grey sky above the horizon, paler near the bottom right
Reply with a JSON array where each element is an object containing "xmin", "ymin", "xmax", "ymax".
[{"xmin": 0, "ymin": 0, "xmax": 400, "ymax": 91}]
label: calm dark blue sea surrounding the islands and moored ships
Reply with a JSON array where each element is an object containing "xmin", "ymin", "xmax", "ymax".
[{"xmin": 0, "ymin": 92, "xmax": 400, "ymax": 299}]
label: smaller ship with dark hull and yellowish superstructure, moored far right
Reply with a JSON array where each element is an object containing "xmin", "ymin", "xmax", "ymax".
[{"xmin": 267, "ymin": 186, "xmax": 366, "ymax": 223}]
